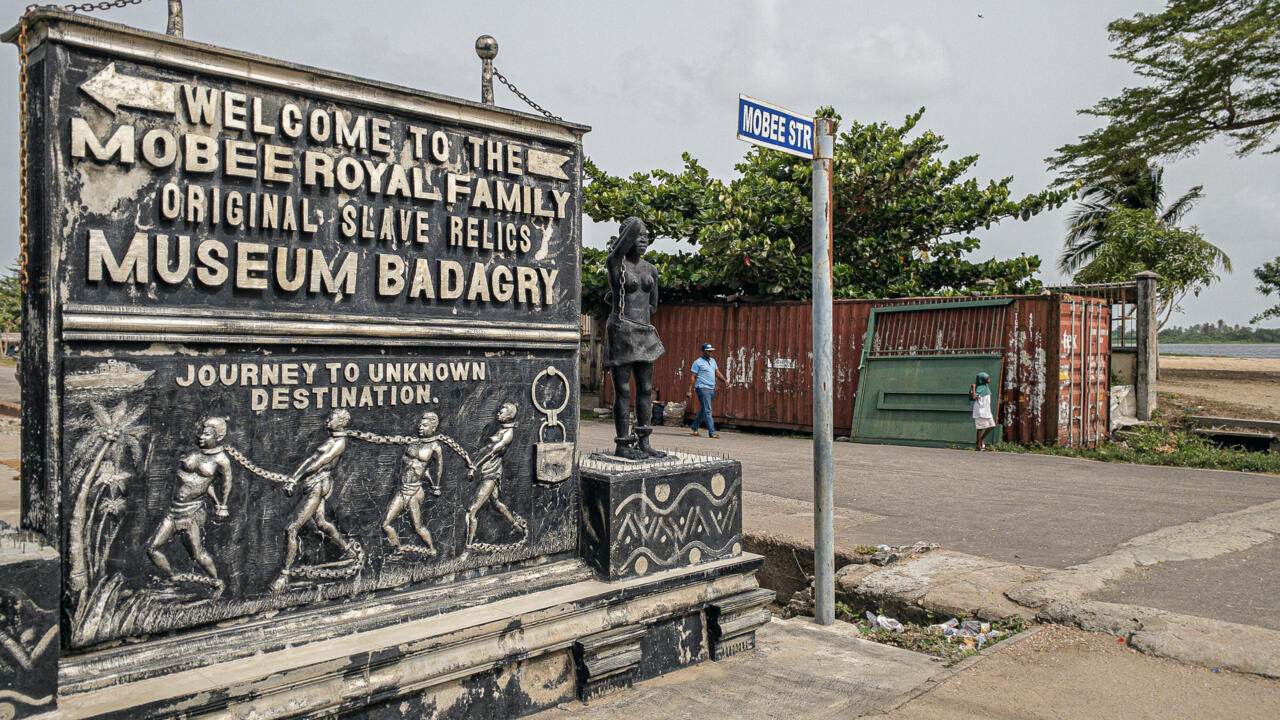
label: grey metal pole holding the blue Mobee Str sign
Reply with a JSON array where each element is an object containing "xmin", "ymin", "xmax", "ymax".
[{"xmin": 813, "ymin": 118, "xmax": 836, "ymax": 625}]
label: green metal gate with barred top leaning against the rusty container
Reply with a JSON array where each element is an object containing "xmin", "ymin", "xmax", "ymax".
[{"xmin": 851, "ymin": 299, "xmax": 1010, "ymax": 447}]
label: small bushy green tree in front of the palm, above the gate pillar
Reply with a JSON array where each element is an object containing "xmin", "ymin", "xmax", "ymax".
[{"xmin": 1073, "ymin": 208, "xmax": 1222, "ymax": 327}]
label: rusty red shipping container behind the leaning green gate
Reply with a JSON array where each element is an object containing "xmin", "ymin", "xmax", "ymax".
[{"xmin": 602, "ymin": 293, "xmax": 1110, "ymax": 445}]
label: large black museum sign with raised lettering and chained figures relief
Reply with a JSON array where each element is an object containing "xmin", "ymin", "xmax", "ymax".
[{"xmin": 23, "ymin": 14, "xmax": 586, "ymax": 647}]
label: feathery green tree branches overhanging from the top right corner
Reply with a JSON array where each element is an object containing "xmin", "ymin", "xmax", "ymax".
[{"xmin": 1048, "ymin": 0, "xmax": 1280, "ymax": 184}]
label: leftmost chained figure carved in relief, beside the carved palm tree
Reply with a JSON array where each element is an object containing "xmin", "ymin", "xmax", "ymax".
[{"xmin": 147, "ymin": 418, "xmax": 232, "ymax": 600}]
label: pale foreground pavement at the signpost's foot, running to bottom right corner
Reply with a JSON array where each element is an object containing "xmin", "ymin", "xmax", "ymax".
[{"xmin": 530, "ymin": 619, "xmax": 1280, "ymax": 720}]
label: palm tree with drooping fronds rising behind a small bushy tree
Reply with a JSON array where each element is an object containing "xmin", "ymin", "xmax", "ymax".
[{"xmin": 1057, "ymin": 158, "xmax": 1231, "ymax": 275}]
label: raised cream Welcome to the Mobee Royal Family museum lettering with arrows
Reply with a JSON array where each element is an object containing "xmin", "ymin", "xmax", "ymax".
[{"xmin": 60, "ymin": 64, "xmax": 576, "ymax": 307}]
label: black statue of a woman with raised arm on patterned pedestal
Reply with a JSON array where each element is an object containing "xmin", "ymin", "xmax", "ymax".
[{"xmin": 604, "ymin": 218, "xmax": 667, "ymax": 460}]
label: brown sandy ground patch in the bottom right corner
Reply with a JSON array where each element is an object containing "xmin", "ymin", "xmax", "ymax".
[{"xmin": 883, "ymin": 625, "xmax": 1280, "ymax": 720}]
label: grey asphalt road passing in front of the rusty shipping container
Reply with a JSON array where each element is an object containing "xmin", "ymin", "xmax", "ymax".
[{"xmin": 581, "ymin": 421, "xmax": 1280, "ymax": 629}]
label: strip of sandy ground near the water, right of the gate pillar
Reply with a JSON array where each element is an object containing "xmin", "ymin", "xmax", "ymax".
[{"xmin": 1157, "ymin": 355, "xmax": 1280, "ymax": 420}]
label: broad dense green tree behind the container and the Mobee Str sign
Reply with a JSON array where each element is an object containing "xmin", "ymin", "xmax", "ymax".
[{"xmin": 584, "ymin": 108, "xmax": 1069, "ymax": 307}]
